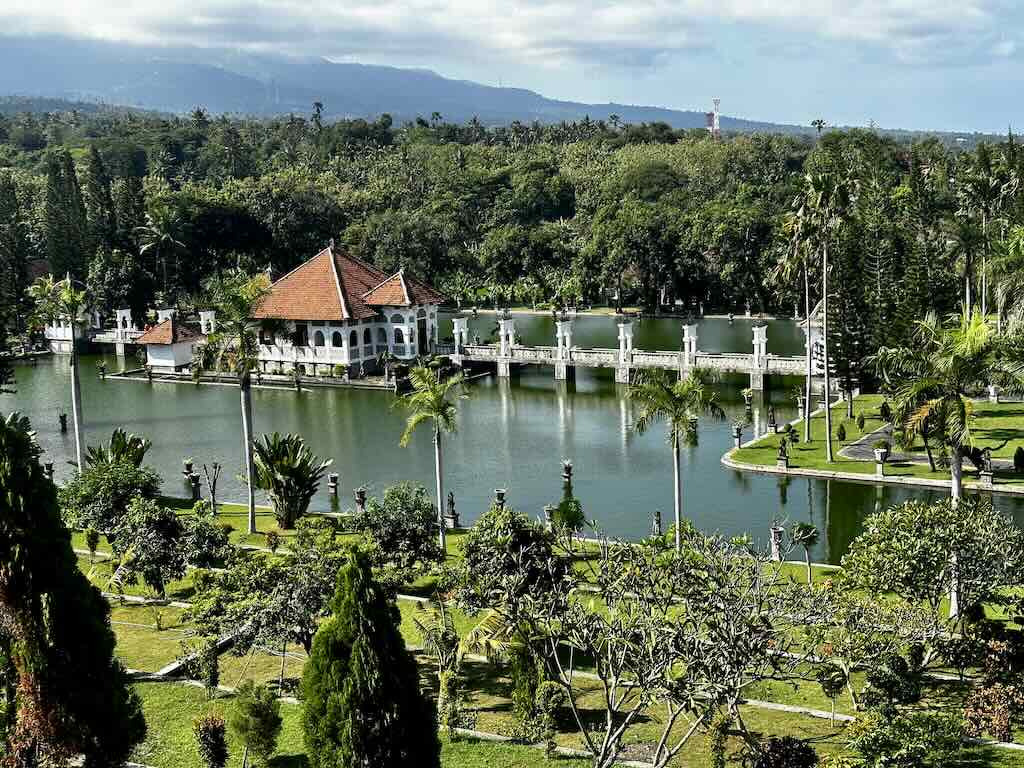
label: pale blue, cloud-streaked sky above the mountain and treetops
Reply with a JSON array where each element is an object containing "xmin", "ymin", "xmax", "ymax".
[{"xmin": 0, "ymin": 0, "xmax": 1024, "ymax": 132}]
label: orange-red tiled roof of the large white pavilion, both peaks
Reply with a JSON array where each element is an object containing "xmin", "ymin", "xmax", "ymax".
[{"xmin": 255, "ymin": 246, "xmax": 440, "ymax": 321}]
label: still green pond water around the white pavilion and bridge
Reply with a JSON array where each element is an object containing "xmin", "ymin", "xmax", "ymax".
[{"xmin": 8, "ymin": 315, "xmax": 1024, "ymax": 562}]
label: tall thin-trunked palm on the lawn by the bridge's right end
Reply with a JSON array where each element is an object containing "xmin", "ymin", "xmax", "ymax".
[{"xmin": 794, "ymin": 173, "xmax": 855, "ymax": 463}]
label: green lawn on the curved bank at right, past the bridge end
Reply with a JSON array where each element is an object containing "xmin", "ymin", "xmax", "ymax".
[{"xmin": 730, "ymin": 394, "xmax": 1024, "ymax": 484}]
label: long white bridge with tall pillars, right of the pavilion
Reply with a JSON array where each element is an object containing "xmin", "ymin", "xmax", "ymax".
[{"xmin": 437, "ymin": 315, "xmax": 807, "ymax": 390}]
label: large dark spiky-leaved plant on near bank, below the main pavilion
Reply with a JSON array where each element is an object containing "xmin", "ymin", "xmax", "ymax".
[{"xmin": 253, "ymin": 432, "xmax": 332, "ymax": 529}]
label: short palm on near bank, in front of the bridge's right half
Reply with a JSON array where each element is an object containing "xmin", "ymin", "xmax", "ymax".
[{"xmin": 629, "ymin": 370, "xmax": 725, "ymax": 552}]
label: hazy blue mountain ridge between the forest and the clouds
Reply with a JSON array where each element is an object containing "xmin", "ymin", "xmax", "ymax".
[{"xmin": 0, "ymin": 37, "xmax": 811, "ymax": 133}]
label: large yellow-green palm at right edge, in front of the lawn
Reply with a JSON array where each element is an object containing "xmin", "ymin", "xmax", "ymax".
[{"xmin": 870, "ymin": 309, "xmax": 1024, "ymax": 504}]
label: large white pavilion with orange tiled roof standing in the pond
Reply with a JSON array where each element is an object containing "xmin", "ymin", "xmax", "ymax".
[{"xmin": 255, "ymin": 242, "xmax": 443, "ymax": 376}]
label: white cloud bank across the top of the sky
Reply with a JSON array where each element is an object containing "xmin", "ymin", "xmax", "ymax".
[{"xmin": 0, "ymin": 0, "xmax": 1019, "ymax": 67}]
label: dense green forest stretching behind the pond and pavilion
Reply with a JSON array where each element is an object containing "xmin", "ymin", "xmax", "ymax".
[{"xmin": 0, "ymin": 103, "xmax": 1024, "ymax": 391}]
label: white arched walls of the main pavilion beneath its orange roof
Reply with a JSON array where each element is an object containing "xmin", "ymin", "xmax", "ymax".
[{"xmin": 259, "ymin": 304, "xmax": 438, "ymax": 376}]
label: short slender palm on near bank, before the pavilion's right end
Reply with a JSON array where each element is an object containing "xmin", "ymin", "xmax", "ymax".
[{"xmin": 395, "ymin": 367, "xmax": 469, "ymax": 552}]
